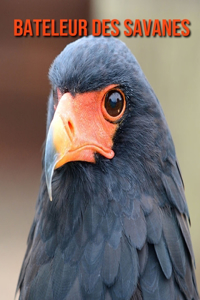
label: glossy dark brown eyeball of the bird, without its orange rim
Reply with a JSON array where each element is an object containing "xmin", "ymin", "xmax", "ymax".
[{"xmin": 104, "ymin": 90, "xmax": 125, "ymax": 117}]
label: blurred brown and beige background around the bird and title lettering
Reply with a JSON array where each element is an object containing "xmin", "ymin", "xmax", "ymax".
[{"xmin": 0, "ymin": 0, "xmax": 200, "ymax": 300}]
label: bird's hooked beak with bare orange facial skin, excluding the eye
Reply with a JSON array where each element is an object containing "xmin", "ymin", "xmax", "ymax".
[{"xmin": 45, "ymin": 85, "xmax": 118, "ymax": 200}]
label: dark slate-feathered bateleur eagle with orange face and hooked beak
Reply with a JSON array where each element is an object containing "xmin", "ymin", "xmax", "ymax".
[{"xmin": 17, "ymin": 35, "xmax": 199, "ymax": 300}]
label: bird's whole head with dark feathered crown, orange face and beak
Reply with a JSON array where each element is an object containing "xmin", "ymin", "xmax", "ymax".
[{"xmin": 44, "ymin": 36, "xmax": 173, "ymax": 199}]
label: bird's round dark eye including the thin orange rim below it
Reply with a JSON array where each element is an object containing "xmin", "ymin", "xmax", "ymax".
[{"xmin": 104, "ymin": 89, "xmax": 125, "ymax": 121}]
